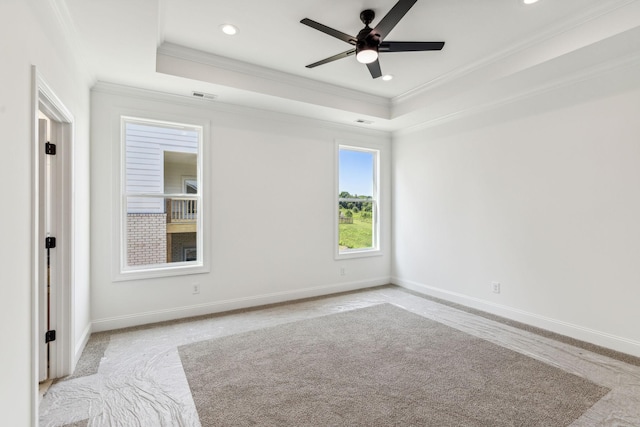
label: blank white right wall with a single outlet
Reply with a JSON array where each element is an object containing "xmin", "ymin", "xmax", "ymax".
[{"xmin": 392, "ymin": 83, "xmax": 640, "ymax": 356}]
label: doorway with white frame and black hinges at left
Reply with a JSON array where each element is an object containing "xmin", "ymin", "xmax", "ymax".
[{"xmin": 31, "ymin": 67, "xmax": 74, "ymax": 416}]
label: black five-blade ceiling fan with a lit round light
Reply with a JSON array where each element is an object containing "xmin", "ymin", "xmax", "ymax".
[{"xmin": 300, "ymin": 0, "xmax": 444, "ymax": 79}]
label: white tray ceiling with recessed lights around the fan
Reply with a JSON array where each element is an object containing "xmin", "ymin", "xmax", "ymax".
[{"xmin": 57, "ymin": 0, "xmax": 640, "ymax": 130}]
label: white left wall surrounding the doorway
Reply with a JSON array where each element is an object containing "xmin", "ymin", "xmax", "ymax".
[{"xmin": 0, "ymin": 0, "xmax": 89, "ymax": 426}]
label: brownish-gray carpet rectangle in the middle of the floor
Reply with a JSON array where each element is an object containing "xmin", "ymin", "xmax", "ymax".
[{"xmin": 179, "ymin": 304, "xmax": 609, "ymax": 427}]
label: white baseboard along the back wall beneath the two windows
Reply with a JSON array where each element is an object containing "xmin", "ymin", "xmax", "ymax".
[{"xmin": 91, "ymin": 277, "xmax": 391, "ymax": 332}]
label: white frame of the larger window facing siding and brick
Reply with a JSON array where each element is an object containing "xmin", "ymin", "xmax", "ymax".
[{"xmin": 114, "ymin": 115, "xmax": 209, "ymax": 281}]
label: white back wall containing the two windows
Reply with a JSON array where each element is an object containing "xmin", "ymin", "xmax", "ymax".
[{"xmin": 91, "ymin": 85, "xmax": 391, "ymax": 330}]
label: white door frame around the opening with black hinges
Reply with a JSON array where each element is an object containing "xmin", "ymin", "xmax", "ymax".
[{"xmin": 31, "ymin": 66, "xmax": 74, "ymax": 418}]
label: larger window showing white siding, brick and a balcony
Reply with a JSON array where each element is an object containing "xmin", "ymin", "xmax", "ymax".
[{"xmin": 121, "ymin": 117, "xmax": 203, "ymax": 273}]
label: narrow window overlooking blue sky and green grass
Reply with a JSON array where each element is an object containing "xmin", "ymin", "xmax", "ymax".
[{"xmin": 337, "ymin": 145, "xmax": 380, "ymax": 257}]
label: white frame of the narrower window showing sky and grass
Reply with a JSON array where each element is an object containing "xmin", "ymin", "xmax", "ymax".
[{"xmin": 333, "ymin": 141, "xmax": 382, "ymax": 260}]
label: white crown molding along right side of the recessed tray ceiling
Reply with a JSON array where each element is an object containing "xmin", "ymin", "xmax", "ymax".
[{"xmin": 391, "ymin": 0, "xmax": 637, "ymax": 107}]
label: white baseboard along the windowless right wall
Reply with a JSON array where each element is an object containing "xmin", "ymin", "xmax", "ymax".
[{"xmin": 391, "ymin": 277, "xmax": 640, "ymax": 357}]
